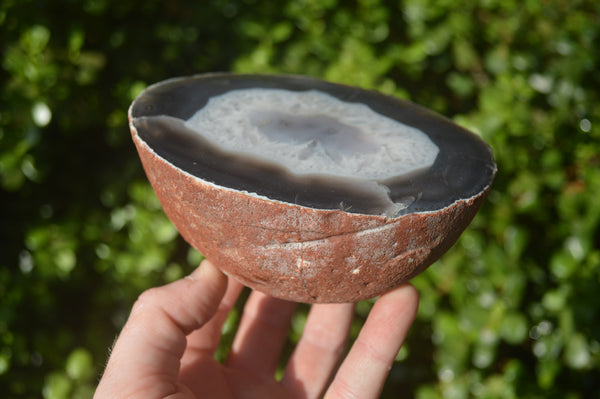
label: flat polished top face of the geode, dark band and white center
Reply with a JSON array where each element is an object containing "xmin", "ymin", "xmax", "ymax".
[{"xmin": 131, "ymin": 75, "xmax": 495, "ymax": 217}]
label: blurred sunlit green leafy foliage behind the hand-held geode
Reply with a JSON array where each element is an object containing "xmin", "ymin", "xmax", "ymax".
[{"xmin": 0, "ymin": 0, "xmax": 600, "ymax": 399}]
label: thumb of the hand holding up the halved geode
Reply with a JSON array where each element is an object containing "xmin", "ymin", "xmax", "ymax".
[{"xmin": 94, "ymin": 260, "xmax": 227, "ymax": 399}]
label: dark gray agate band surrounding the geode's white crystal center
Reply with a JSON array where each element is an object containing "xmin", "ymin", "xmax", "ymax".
[{"xmin": 129, "ymin": 73, "xmax": 496, "ymax": 216}]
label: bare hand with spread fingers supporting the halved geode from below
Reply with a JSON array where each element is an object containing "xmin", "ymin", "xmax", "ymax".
[{"xmin": 94, "ymin": 260, "xmax": 418, "ymax": 399}]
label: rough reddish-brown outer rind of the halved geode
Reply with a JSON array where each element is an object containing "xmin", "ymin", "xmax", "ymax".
[{"xmin": 130, "ymin": 73, "xmax": 491, "ymax": 303}]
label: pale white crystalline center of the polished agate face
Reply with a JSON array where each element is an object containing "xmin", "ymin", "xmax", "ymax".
[{"xmin": 186, "ymin": 89, "xmax": 439, "ymax": 180}]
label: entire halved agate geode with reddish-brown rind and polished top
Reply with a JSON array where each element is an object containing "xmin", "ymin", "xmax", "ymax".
[{"xmin": 129, "ymin": 73, "xmax": 496, "ymax": 303}]
